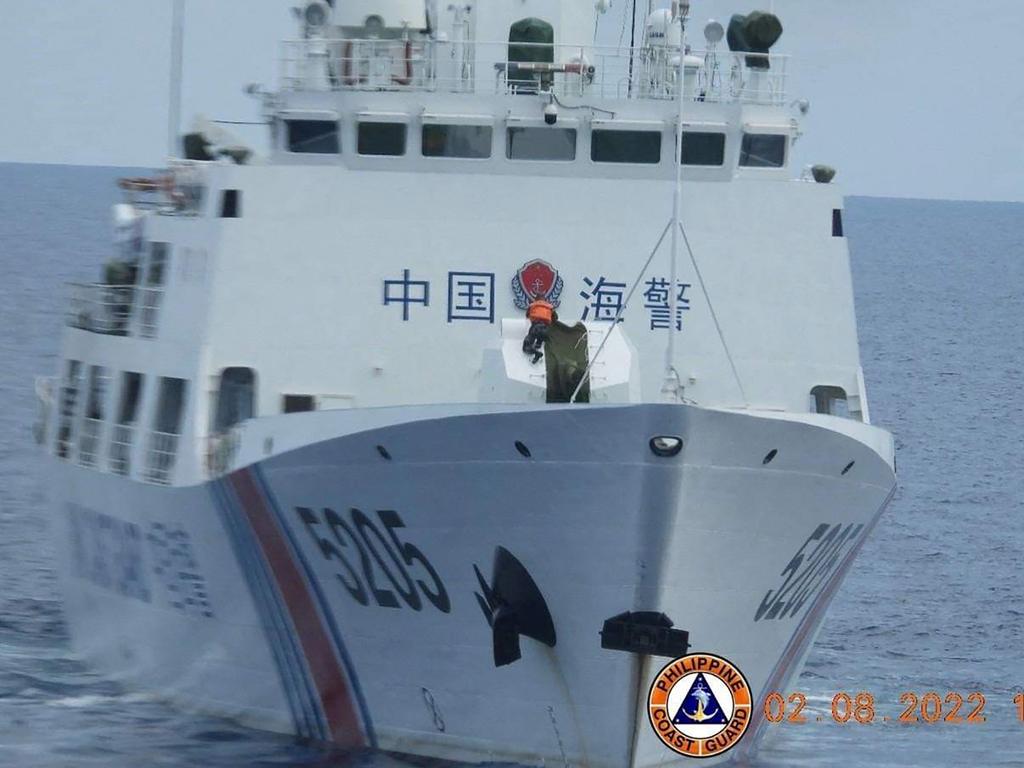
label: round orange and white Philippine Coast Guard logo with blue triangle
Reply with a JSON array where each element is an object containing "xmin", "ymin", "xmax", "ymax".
[{"xmin": 647, "ymin": 653, "xmax": 751, "ymax": 758}]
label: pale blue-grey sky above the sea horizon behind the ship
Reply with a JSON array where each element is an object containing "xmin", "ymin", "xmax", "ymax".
[{"xmin": 0, "ymin": 0, "xmax": 1024, "ymax": 202}]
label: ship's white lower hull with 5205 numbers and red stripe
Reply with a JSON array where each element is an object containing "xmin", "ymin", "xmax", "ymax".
[{"xmin": 51, "ymin": 406, "xmax": 895, "ymax": 768}]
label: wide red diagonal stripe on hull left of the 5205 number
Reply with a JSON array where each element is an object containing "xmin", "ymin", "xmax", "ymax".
[{"xmin": 228, "ymin": 470, "xmax": 367, "ymax": 748}]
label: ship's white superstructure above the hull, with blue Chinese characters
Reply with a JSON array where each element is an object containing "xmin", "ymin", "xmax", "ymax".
[{"xmin": 39, "ymin": 0, "xmax": 868, "ymax": 493}]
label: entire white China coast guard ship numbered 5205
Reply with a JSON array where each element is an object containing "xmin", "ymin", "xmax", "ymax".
[{"xmin": 37, "ymin": 0, "xmax": 895, "ymax": 768}]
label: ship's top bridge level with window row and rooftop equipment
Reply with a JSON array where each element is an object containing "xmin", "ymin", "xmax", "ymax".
[{"xmin": 251, "ymin": 0, "xmax": 794, "ymax": 181}]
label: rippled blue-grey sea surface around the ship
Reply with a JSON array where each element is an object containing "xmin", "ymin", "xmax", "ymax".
[{"xmin": 0, "ymin": 165, "xmax": 1024, "ymax": 768}]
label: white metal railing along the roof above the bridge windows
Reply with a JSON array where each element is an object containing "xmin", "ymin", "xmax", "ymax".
[{"xmin": 280, "ymin": 39, "xmax": 790, "ymax": 105}]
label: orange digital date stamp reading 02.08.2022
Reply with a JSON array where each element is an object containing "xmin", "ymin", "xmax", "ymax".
[{"xmin": 764, "ymin": 691, "xmax": 1024, "ymax": 725}]
